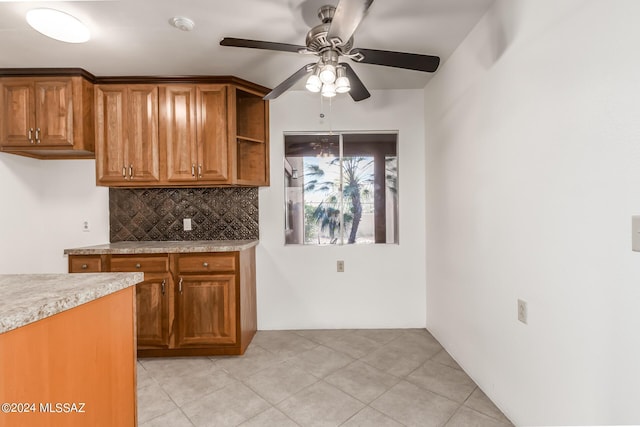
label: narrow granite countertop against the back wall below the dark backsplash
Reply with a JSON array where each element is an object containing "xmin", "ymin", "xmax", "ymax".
[{"xmin": 64, "ymin": 240, "xmax": 259, "ymax": 255}]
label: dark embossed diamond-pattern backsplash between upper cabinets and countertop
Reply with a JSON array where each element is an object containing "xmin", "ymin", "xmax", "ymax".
[{"xmin": 109, "ymin": 187, "xmax": 258, "ymax": 242}]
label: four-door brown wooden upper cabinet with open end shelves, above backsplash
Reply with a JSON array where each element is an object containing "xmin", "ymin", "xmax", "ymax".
[{"xmin": 95, "ymin": 77, "xmax": 269, "ymax": 187}]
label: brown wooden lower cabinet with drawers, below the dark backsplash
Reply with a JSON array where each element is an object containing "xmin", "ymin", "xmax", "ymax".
[{"xmin": 69, "ymin": 247, "xmax": 257, "ymax": 357}]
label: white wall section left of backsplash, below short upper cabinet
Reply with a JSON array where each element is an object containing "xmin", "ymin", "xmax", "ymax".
[{"xmin": 0, "ymin": 153, "xmax": 109, "ymax": 274}]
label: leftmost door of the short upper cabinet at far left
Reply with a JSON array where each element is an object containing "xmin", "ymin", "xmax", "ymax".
[{"xmin": 0, "ymin": 78, "xmax": 36, "ymax": 146}]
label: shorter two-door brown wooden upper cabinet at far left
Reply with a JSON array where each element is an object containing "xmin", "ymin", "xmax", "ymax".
[{"xmin": 0, "ymin": 70, "xmax": 94, "ymax": 159}]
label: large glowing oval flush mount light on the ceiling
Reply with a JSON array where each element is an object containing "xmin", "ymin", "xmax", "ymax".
[{"xmin": 27, "ymin": 8, "xmax": 91, "ymax": 43}]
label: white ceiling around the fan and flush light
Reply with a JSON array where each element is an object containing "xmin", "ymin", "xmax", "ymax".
[{"xmin": 0, "ymin": 0, "xmax": 494, "ymax": 89}]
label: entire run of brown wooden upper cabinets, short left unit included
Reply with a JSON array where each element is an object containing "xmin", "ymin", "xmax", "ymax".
[{"xmin": 0, "ymin": 68, "xmax": 269, "ymax": 187}]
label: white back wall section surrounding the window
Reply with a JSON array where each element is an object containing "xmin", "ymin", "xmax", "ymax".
[{"xmin": 257, "ymin": 90, "xmax": 426, "ymax": 329}]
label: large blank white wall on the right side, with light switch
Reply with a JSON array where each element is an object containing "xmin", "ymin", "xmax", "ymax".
[{"xmin": 425, "ymin": 0, "xmax": 640, "ymax": 425}]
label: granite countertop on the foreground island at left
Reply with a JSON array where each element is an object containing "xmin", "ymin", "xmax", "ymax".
[{"xmin": 0, "ymin": 273, "xmax": 144, "ymax": 334}]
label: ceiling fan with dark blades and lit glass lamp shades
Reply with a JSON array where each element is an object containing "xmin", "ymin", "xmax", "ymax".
[{"xmin": 220, "ymin": 0, "xmax": 440, "ymax": 101}]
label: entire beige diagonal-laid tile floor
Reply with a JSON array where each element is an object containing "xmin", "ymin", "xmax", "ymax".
[{"xmin": 137, "ymin": 329, "xmax": 510, "ymax": 427}]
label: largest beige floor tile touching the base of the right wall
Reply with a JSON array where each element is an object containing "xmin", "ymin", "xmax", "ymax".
[{"xmin": 407, "ymin": 360, "xmax": 476, "ymax": 403}]
